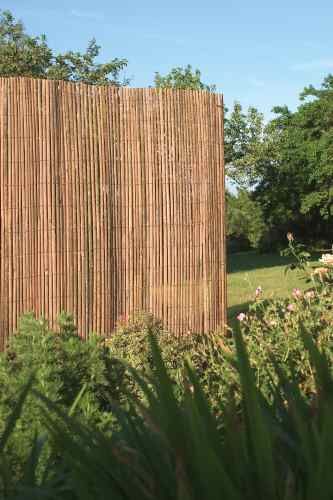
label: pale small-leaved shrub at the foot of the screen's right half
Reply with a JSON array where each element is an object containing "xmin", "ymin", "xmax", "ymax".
[{"xmin": 106, "ymin": 312, "xmax": 237, "ymax": 414}]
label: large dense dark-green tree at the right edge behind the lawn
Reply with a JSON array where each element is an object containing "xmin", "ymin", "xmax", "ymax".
[{"xmin": 255, "ymin": 76, "xmax": 333, "ymax": 241}]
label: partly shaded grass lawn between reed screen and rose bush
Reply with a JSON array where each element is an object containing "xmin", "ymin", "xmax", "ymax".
[{"xmin": 228, "ymin": 252, "xmax": 316, "ymax": 321}]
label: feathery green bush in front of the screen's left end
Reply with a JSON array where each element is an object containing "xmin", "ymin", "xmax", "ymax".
[{"xmin": 0, "ymin": 314, "xmax": 118, "ymax": 480}]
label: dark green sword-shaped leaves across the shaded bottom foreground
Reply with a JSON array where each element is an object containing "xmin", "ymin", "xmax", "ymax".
[{"xmin": 0, "ymin": 325, "xmax": 333, "ymax": 500}]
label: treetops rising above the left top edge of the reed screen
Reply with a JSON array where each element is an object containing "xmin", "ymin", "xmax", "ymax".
[{"xmin": 0, "ymin": 11, "xmax": 128, "ymax": 86}]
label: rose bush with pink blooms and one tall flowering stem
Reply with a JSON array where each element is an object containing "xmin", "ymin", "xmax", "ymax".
[{"xmin": 238, "ymin": 240, "xmax": 333, "ymax": 396}]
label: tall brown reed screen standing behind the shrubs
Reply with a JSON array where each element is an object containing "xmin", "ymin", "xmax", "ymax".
[{"xmin": 0, "ymin": 78, "xmax": 225, "ymax": 343}]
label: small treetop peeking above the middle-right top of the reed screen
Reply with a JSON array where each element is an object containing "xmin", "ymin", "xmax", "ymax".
[{"xmin": 154, "ymin": 64, "xmax": 216, "ymax": 92}]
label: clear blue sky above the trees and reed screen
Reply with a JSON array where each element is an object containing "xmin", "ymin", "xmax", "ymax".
[{"xmin": 6, "ymin": 0, "xmax": 333, "ymax": 117}]
